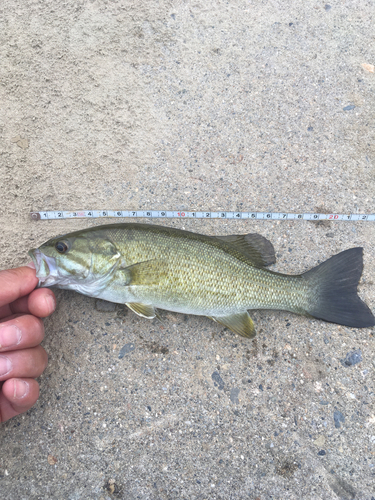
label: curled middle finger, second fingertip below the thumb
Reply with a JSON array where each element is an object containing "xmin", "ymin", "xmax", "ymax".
[{"xmin": 0, "ymin": 314, "xmax": 44, "ymax": 352}]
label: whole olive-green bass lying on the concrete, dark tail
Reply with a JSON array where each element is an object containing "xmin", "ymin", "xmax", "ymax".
[{"xmin": 29, "ymin": 223, "xmax": 375, "ymax": 338}]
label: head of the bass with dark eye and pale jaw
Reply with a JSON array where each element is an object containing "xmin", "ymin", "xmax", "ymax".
[{"xmin": 29, "ymin": 231, "xmax": 120, "ymax": 297}]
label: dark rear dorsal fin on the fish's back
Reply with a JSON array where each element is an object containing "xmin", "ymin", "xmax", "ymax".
[{"xmin": 214, "ymin": 233, "xmax": 276, "ymax": 267}]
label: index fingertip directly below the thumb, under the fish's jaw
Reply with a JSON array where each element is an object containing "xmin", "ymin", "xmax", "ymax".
[{"xmin": 0, "ymin": 288, "xmax": 56, "ymax": 318}]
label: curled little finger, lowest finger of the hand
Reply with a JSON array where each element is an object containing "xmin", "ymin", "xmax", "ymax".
[{"xmin": 0, "ymin": 378, "xmax": 39, "ymax": 422}]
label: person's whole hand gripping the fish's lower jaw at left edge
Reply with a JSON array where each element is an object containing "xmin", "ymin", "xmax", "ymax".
[{"xmin": 0, "ymin": 263, "xmax": 56, "ymax": 422}]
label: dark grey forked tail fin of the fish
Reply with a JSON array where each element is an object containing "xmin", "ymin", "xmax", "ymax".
[{"xmin": 302, "ymin": 247, "xmax": 375, "ymax": 328}]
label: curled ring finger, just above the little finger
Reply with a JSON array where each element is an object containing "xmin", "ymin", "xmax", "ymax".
[{"xmin": 0, "ymin": 346, "xmax": 48, "ymax": 381}]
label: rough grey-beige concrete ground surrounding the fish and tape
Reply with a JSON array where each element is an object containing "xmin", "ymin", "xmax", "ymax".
[{"xmin": 0, "ymin": 0, "xmax": 375, "ymax": 500}]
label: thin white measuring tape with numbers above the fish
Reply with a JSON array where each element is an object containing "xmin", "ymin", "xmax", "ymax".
[{"xmin": 30, "ymin": 210, "xmax": 375, "ymax": 221}]
